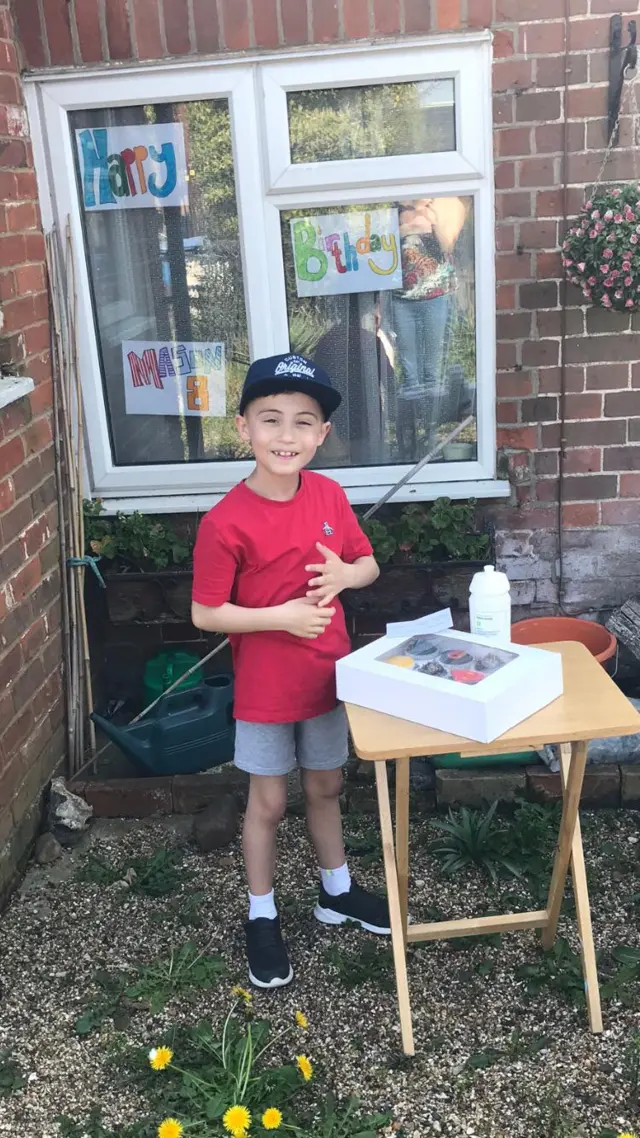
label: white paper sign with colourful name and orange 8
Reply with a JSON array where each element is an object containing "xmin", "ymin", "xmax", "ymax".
[{"xmin": 122, "ymin": 340, "xmax": 227, "ymax": 419}]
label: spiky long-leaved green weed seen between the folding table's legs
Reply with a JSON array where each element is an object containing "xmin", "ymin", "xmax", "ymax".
[{"xmin": 430, "ymin": 802, "xmax": 520, "ymax": 884}]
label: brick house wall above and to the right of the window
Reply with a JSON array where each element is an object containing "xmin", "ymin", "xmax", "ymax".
[{"xmin": 9, "ymin": 0, "xmax": 640, "ymax": 612}]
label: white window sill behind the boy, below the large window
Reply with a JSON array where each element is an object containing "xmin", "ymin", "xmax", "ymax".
[{"xmin": 96, "ymin": 479, "xmax": 511, "ymax": 514}]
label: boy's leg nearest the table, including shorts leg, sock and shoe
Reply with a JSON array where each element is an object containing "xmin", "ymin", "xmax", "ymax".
[{"xmin": 296, "ymin": 704, "xmax": 391, "ymax": 934}]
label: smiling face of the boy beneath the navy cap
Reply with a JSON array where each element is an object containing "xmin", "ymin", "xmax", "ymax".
[{"xmin": 236, "ymin": 391, "xmax": 331, "ymax": 475}]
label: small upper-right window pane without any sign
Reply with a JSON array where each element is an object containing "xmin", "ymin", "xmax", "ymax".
[{"xmin": 287, "ymin": 79, "xmax": 456, "ymax": 163}]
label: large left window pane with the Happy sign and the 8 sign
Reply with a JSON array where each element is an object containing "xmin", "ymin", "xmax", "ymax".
[{"xmin": 69, "ymin": 99, "xmax": 248, "ymax": 464}]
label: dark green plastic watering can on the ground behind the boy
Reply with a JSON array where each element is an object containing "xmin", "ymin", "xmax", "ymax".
[{"xmin": 91, "ymin": 675, "xmax": 236, "ymax": 775}]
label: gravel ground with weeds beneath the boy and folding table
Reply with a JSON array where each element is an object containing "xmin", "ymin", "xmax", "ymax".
[{"xmin": 0, "ymin": 811, "xmax": 640, "ymax": 1138}]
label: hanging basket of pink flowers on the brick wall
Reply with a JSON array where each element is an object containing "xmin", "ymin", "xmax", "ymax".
[{"xmin": 563, "ymin": 182, "xmax": 640, "ymax": 312}]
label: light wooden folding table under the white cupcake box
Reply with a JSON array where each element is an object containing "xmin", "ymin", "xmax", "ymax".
[{"xmin": 346, "ymin": 642, "xmax": 640, "ymax": 1055}]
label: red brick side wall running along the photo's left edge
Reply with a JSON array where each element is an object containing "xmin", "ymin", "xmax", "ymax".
[{"xmin": 0, "ymin": 0, "xmax": 64, "ymax": 904}]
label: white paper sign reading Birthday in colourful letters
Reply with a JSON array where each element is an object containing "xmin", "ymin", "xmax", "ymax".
[{"xmin": 289, "ymin": 209, "xmax": 402, "ymax": 296}]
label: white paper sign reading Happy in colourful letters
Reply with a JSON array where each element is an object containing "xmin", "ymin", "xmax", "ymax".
[{"xmin": 75, "ymin": 123, "xmax": 189, "ymax": 209}]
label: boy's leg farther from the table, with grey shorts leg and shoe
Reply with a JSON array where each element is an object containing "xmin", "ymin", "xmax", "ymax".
[{"xmin": 235, "ymin": 720, "xmax": 295, "ymax": 988}]
